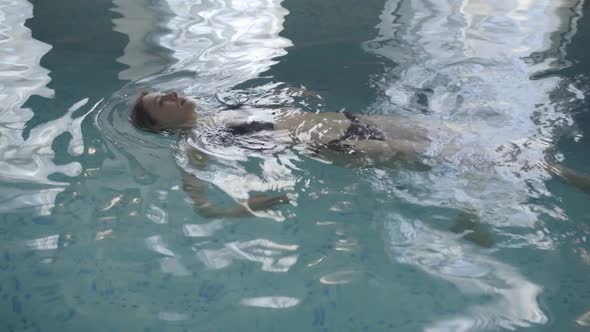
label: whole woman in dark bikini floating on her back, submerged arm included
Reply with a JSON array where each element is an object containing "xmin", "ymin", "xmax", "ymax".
[{"xmin": 129, "ymin": 92, "xmax": 590, "ymax": 223}]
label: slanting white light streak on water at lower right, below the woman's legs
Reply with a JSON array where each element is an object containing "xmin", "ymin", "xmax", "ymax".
[{"xmin": 385, "ymin": 216, "xmax": 547, "ymax": 331}]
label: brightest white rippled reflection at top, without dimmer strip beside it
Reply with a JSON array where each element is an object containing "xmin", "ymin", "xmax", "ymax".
[{"xmin": 159, "ymin": 0, "xmax": 292, "ymax": 92}]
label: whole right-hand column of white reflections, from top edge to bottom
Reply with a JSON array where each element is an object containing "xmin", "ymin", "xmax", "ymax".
[{"xmin": 365, "ymin": 0, "xmax": 583, "ymax": 331}]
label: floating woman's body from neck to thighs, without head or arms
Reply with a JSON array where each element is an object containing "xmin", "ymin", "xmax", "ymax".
[{"xmin": 198, "ymin": 106, "xmax": 472, "ymax": 158}]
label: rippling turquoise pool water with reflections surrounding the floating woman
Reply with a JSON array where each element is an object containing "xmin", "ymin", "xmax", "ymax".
[{"xmin": 0, "ymin": 0, "xmax": 590, "ymax": 331}]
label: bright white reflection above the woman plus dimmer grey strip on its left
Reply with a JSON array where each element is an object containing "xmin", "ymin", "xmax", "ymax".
[{"xmin": 114, "ymin": 0, "xmax": 292, "ymax": 84}]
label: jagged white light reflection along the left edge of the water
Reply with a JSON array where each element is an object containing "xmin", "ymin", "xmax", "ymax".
[{"xmin": 0, "ymin": 0, "xmax": 93, "ymax": 215}]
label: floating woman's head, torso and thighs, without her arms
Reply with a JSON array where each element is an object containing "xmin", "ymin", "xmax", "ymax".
[{"xmin": 130, "ymin": 92, "xmax": 461, "ymax": 166}]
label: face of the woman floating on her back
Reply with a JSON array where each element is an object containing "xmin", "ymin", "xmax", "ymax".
[{"xmin": 142, "ymin": 92, "xmax": 196, "ymax": 129}]
